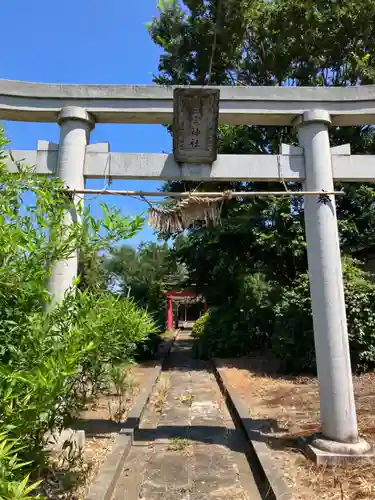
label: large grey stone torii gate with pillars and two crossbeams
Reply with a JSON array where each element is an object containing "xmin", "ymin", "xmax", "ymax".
[{"xmin": 0, "ymin": 80, "xmax": 375, "ymax": 462}]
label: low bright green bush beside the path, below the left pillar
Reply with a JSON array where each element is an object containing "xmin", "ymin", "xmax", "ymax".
[{"xmin": 0, "ymin": 293, "xmax": 156, "ymax": 461}]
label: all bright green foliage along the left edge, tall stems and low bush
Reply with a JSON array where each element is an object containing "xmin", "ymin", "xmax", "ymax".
[{"xmin": 0, "ymin": 131, "xmax": 156, "ymax": 492}]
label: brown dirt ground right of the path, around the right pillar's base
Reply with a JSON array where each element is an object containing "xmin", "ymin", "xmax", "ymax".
[{"xmin": 221, "ymin": 357, "xmax": 375, "ymax": 500}]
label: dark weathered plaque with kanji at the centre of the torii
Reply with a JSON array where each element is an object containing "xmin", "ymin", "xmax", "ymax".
[{"xmin": 173, "ymin": 88, "xmax": 220, "ymax": 164}]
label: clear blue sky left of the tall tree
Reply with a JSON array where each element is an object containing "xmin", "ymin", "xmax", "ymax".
[{"xmin": 0, "ymin": 0, "xmax": 171, "ymax": 246}]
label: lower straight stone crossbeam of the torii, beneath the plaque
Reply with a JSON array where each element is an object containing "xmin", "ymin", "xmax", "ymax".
[{"xmin": 7, "ymin": 148, "xmax": 375, "ymax": 182}]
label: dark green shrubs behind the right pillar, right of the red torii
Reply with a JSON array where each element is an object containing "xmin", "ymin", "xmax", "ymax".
[{"xmin": 194, "ymin": 259, "xmax": 375, "ymax": 373}]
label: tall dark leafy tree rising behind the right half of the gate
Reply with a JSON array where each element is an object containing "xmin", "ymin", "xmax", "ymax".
[{"xmin": 148, "ymin": 0, "xmax": 375, "ymax": 370}]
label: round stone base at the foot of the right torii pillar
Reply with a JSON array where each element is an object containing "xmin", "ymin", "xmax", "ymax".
[{"xmin": 301, "ymin": 434, "xmax": 375, "ymax": 467}]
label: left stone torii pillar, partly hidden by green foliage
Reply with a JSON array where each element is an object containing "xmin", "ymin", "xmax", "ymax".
[{"xmin": 48, "ymin": 106, "xmax": 94, "ymax": 306}]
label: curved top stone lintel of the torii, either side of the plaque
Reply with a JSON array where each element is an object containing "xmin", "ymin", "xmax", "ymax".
[{"xmin": 0, "ymin": 80, "xmax": 375, "ymax": 125}]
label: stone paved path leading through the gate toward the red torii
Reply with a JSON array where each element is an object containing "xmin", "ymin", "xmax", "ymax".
[{"xmin": 112, "ymin": 333, "xmax": 261, "ymax": 500}]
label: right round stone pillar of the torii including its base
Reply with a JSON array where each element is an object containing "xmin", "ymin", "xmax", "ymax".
[{"xmin": 295, "ymin": 110, "xmax": 371, "ymax": 465}]
